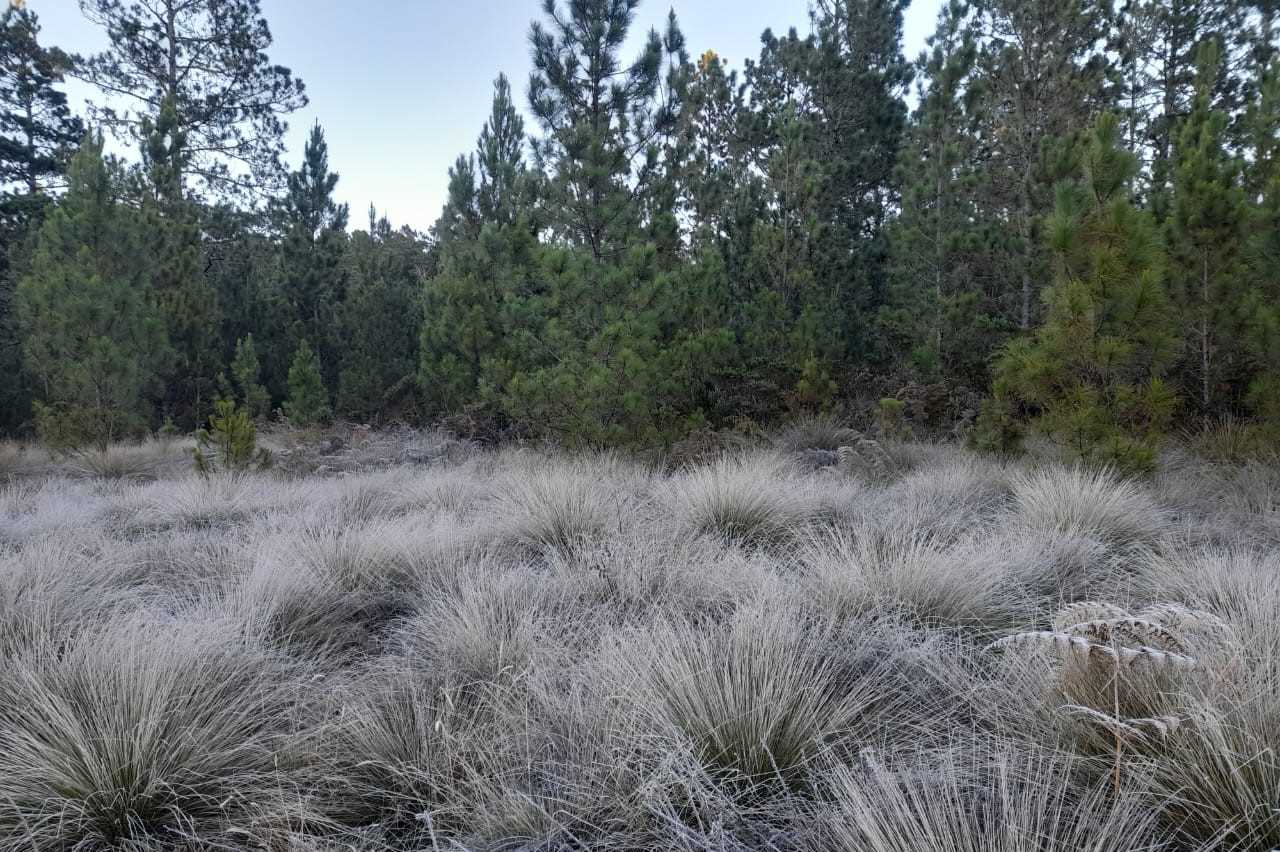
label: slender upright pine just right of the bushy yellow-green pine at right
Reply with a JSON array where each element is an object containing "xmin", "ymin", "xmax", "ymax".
[{"xmin": 1167, "ymin": 41, "xmax": 1247, "ymax": 417}]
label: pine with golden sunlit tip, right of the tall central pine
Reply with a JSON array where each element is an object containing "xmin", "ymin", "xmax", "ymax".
[{"xmin": 664, "ymin": 47, "xmax": 793, "ymax": 417}]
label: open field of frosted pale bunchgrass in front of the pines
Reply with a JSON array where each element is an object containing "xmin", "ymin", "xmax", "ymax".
[{"xmin": 0, "ymin": 430, "xmax": 1280, "ymax": 852}]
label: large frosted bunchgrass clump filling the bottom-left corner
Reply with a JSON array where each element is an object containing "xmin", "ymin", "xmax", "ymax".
[{"xmin": 0, "ymin": 617, "xmax": 297, "ymax": 849}]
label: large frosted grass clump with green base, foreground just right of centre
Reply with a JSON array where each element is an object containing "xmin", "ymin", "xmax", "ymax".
[{"xmin": 612, "ymin": 601, "xmax": 952, "ymax": 783}]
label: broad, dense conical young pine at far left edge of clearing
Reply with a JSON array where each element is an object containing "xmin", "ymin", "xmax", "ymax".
[{"xmin": 17, "ymin": 138, "xmax": 166, "ymax": 449}]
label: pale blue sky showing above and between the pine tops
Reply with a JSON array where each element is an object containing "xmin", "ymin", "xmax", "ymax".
[{"xmin": 27, "ymin": 0, "xmax": 941, "ymax": 230}]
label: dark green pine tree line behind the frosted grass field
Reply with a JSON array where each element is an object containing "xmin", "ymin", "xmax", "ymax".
[{"xmin": 0, "ymin": 0, "xmax": 1280, "ymax": 467}]
